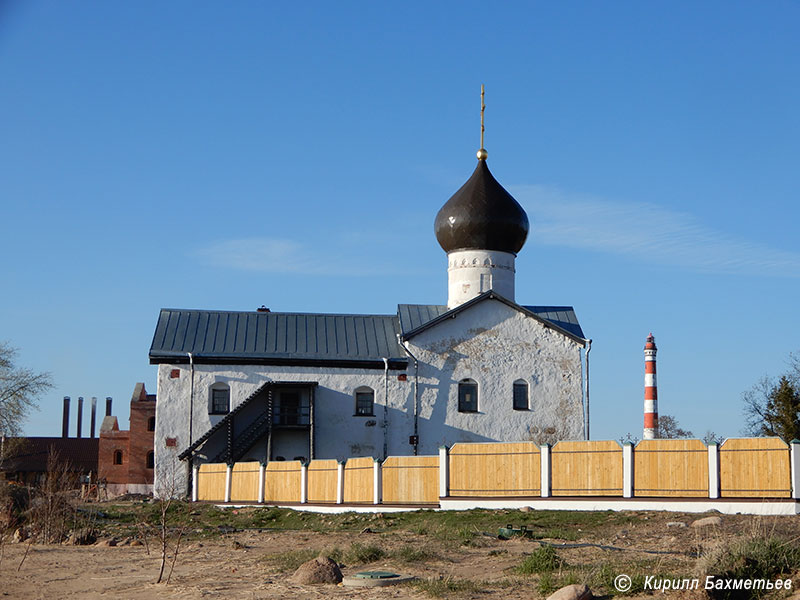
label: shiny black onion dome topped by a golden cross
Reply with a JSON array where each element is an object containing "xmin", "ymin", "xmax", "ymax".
[{"xmin": 434, "ymin": 160, "xmax": 529, "ymax": 254}]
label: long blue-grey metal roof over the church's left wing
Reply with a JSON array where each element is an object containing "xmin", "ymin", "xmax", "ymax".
[{"xmin": 150, "ymin": 308, "xmax": 407, "ymax": 368}]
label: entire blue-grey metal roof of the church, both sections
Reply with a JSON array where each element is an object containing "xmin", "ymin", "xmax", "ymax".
[{"xmin": 150, "ymin": 292, "xmax": 584, "ymax": 369}]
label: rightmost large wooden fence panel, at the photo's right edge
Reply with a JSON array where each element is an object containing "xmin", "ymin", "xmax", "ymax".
[{"xmin": 719, "ymin": 438, "xmax": 792, "ymax": 498}]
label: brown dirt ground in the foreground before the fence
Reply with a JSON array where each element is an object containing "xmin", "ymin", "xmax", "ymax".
[{"xmin": 0, "ymin": 513, "xmax": 800, "ymax": 600}]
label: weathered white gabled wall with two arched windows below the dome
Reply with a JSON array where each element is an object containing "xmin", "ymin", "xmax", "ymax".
[{"xmin": 408, "ymin": 300, "xmax": 583, "ymax": 454}]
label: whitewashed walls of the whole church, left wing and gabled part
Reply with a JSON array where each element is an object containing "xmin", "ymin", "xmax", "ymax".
[{"xmin": 155, "ymin": 300, "xmax": 583, "ymax": 493}]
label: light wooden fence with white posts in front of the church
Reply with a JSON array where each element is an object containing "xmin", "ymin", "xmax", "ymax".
[{"xmin": 194, "ymin": 438, "xmax": 800, "ymax": 505}]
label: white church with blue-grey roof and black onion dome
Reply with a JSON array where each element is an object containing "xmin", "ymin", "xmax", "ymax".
[{"xmin": 150, "ymin": 125, "xmax": 588, "ymax": 495}]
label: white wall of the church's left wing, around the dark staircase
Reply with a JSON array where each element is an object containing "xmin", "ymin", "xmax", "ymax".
[{"xmin": 155, "ymin": 364, "xmax": 413, "ymax": 490}]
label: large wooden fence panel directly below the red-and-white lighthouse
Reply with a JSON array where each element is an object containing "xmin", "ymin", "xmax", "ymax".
[{"xmin": 633, "ymin": 440, "xmax": 708, "ymax": 498}]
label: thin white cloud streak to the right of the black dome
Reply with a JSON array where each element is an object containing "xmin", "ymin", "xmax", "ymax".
[{"xmin": 513, "ymin": 185, "xmax": 800, "ymax": 277}]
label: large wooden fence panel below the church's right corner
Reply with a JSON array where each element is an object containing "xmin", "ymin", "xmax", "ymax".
[{"xmin": 550, "ymin": 441, "xmax": 622, "ymax": 496}]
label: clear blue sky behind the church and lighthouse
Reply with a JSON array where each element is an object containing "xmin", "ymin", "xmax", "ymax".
[{"xmin": 0, "ymin": 0, "xmax": 800, "ymax": 439}]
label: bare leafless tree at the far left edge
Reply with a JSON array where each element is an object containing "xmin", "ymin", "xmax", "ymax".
[{"xmin": 0, "ymin": 342, "xmax": 53, "ymax": 436}]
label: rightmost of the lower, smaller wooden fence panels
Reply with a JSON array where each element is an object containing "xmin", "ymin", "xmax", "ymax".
[{"xmin": 381, "ymin": 456, "xmax": 439, "ymax": 504}]
